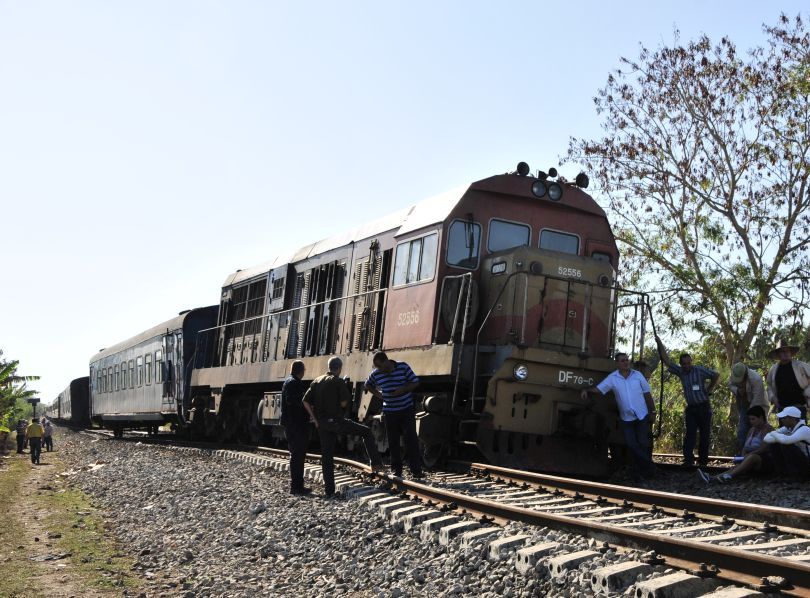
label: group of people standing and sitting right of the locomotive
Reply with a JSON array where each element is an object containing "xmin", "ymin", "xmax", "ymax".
[{"xmin": 582, "ymin": 336, "xmax": 810, "ymax": 483}]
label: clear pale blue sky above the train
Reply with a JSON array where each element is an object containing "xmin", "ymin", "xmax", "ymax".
[{"xmin": 0, "ymin": 0, "xmax": 807, "ymax": 402}]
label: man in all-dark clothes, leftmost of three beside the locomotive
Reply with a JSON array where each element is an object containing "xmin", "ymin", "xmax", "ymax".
[{"xmin": 281, "ymin": 360, "xmax": 312, "ymax": 494}]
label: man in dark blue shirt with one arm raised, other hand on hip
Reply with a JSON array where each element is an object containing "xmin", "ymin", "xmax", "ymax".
[{"xmin": 655, "ymin": 336, "xmax": 720, "ymax": 467}]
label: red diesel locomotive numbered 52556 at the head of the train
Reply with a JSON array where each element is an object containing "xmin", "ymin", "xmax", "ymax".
[{"xmin": 184, "ymin": 163, "xmax": 648, "ymax": 475}]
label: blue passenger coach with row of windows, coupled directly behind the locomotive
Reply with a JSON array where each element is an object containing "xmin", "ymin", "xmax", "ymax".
[{"xmin": 89, "ymin": 305, "xmax": 217, "ymax": 437}]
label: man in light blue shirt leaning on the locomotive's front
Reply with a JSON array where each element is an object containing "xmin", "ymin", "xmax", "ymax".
[{"xmin": 581, "ymin": 353, "xmax": 656, "ymax": 477}]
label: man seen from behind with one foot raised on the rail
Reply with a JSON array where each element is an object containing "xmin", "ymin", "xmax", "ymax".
[{"xmin": 303, "ymin": 357, "xmax": 383, "ymax": 498}]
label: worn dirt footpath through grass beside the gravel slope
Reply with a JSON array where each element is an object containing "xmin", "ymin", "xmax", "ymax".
[{"xmin": 7, "ymin": 452, "xmax": 121, "ymax": 598}]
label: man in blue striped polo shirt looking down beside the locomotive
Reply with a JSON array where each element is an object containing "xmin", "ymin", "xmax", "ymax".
[{"xmin": 365, "ymin": 351, "xmax": 422, "ymax": 478}]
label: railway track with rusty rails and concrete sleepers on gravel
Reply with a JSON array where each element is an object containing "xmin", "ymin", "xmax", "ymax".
[{"xmin": 88, "ymin": 437, "xmax": 810, "ymax": 598}]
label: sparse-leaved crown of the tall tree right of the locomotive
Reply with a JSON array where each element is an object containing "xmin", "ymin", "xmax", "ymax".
[{"xmin": 568, "ymin": 15, "xmax": 810, "ymax": 364}]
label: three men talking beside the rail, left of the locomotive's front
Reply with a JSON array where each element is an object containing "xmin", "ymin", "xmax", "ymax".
[{"xmin": 281, "ymin": 351, "xmax": 422, "ymax": 498}]
